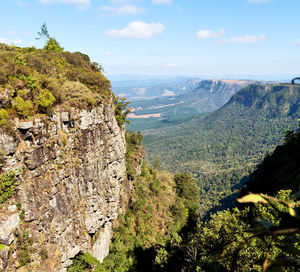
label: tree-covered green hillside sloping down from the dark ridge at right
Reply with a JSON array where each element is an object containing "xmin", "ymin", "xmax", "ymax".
[{"xmin": 144, "ymin": 84, "xmax": 300, "ymax": 217}]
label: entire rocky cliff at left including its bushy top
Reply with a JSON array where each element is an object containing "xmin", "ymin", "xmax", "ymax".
[{"xmin": 0, "ymin": 47, "xmax": 130, "ymax": 271}]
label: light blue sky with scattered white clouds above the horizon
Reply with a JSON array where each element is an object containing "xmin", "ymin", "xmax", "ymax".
[{"xmin": 0, "ymin": 0, "xmax": 300, "ymax": 77}]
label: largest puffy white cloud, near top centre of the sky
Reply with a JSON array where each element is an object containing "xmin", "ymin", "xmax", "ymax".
[{"xmin": 106, "ymin": 21, "xmax": 165, "ymax": 39}]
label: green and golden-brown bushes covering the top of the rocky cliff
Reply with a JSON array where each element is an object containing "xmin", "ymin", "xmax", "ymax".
[{"xmin": 0, "ymin": 42, "xmax": 111, "ymax": 126}]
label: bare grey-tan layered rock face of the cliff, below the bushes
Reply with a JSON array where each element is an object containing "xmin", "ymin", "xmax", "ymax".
[{"xmin": 0, "ymin": 102, "xmax": 129, "ymax": 271}]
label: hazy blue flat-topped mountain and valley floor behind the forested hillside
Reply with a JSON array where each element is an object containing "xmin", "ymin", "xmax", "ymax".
[{"xmin": 127, "ymin": 79, "xmax": 269, "ymax": 130}]
